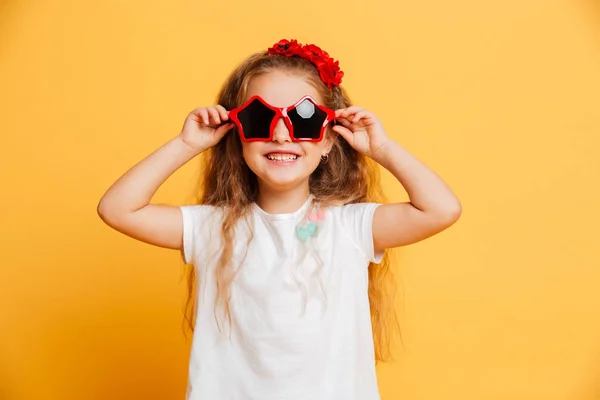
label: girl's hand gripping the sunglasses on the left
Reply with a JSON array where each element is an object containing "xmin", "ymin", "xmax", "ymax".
[{"xmin": 179, "ymin": 105, "xmax": 235, "ymax": 153}]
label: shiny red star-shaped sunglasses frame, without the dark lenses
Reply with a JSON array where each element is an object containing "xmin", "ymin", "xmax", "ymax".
[{"xmin": 229, "ymin": 95, "xmax": 335, "ymax": 142}]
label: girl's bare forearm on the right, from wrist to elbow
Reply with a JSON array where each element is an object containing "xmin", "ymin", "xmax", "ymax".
[{"xmin": 374, "ymin": 139, "xmax": 461, "ymax": 215}]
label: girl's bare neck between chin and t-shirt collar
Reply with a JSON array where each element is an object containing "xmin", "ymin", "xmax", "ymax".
[{"xmin": 256, "ymin": 182, "xmax": 310, "ymax": 214}]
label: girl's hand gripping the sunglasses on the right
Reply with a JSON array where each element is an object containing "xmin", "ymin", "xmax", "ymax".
[{"xmin": 332, "ymin": 106, "xmax": 390, "ymax": 159}]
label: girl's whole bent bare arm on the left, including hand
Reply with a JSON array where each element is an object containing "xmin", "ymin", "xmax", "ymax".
[{"xmin": 98, "ymin": 106, "xmax": 232, "ymax": 249}]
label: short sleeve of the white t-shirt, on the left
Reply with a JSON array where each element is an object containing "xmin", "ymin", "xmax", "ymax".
[{"xmin": 179, "ymin": 205, "xmax": 221, "ymax": 264}]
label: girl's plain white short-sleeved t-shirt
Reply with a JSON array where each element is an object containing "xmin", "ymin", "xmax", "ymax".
[{"xmin": 181, "ymin": 199, "xmax": 382, "ymax": 400}]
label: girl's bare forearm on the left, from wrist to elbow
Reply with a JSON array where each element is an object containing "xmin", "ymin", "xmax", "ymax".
[{"xmin": 98, "ymin": 137, "xmax": 198, "ymax": 214}]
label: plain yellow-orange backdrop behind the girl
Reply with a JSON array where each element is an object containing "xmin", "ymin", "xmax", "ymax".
[{"xmin": 0, "ymin": 0, "xmax": 600, "ymax": 400}]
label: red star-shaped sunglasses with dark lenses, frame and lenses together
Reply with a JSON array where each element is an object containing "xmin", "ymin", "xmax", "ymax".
[{"xmin": 229, "ymin": 96, "xmax": 335, "ymax": 142}]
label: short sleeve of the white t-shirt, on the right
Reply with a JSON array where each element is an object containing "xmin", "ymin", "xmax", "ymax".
[{"xmin": 340, "ymin": 203, "xmax": 384, "ymax": 264}]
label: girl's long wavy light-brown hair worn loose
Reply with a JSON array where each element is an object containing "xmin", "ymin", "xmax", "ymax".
[{"xmin": 185, "ymin": 52, "xmax": 398, "ymax": 361}]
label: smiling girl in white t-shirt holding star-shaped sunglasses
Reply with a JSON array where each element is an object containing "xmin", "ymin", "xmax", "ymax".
[{"xmin": 98, "ymin": 40, "xmax": 461, "ymax": 400}]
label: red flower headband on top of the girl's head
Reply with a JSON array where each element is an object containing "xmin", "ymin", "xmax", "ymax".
[{"xmin": 267, "ymin": 39, "xmax": 344, "ymax": 89}]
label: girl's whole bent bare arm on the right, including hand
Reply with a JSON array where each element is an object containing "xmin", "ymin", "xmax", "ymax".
[{"xmin": 333, "ymin": 106, "xmax": 461, "ymax": 253}]
